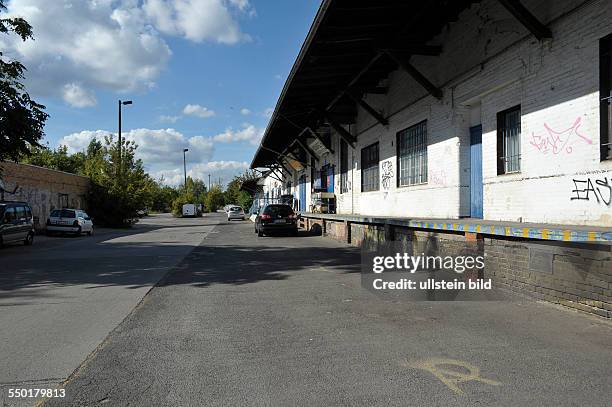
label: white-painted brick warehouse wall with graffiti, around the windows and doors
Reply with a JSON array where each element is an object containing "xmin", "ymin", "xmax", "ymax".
[{"xmin": 276, "ymin": 0, "xmax": 612, "ymax": 226}]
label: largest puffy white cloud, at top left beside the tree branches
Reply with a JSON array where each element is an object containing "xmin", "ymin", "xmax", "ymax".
[{"xmin": 0, "ymin": 0, "xmax": 171, "ymax": 106}]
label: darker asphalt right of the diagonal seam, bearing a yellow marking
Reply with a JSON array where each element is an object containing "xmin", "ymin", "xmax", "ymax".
[{"xmin": 33, "ymin": 215, "xmax": 612, "ymax": 407}]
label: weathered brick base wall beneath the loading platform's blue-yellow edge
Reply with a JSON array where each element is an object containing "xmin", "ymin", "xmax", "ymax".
[{"xmin": 301, "ymin": 215, "xmax": 612, "ymax": 318}]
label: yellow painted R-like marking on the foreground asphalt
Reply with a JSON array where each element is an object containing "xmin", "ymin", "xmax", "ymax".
[{"xmin": 407, "ymin": 359, "xmax": 501, "ymax": 394}]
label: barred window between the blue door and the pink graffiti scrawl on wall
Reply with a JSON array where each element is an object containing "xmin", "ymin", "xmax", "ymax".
[{"xmin": 497, "ymin": 105, "xmax": 521, "ymax": 175}]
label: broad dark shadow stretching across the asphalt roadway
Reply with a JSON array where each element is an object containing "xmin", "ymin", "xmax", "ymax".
[{"xmin": 0, "ymin": 217, "xmax": 360, "ymax": 300}]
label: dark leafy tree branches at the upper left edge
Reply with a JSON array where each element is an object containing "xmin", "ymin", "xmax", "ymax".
[{"xmin": 0, "ymin": 0, "xmax": 48, "ymax": 169}]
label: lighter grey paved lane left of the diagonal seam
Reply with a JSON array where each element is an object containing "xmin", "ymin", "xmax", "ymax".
[{"xmin": 0, "ymin": 215, "xmax": 217, "ymax": 405}]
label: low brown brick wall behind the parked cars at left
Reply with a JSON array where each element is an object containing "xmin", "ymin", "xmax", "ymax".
[{"xmin": 0, "ymin": 162, "xmax": 89, "ymax": 231}]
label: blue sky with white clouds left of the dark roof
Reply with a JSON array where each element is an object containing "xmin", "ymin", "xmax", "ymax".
[{"xmin": 0, "ymin": 0, "xmax": 320, "ymax": 185}]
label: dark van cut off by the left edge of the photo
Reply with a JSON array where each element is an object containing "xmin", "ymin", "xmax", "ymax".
[{"xmin": 0, "ymin": 201, "xmax": 34, "ymax": 247}]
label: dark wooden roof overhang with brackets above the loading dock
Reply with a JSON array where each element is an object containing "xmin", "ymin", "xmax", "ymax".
[{"xmin": 251, "ymin": 0, "xmax": 478, "ymax": 168}]
